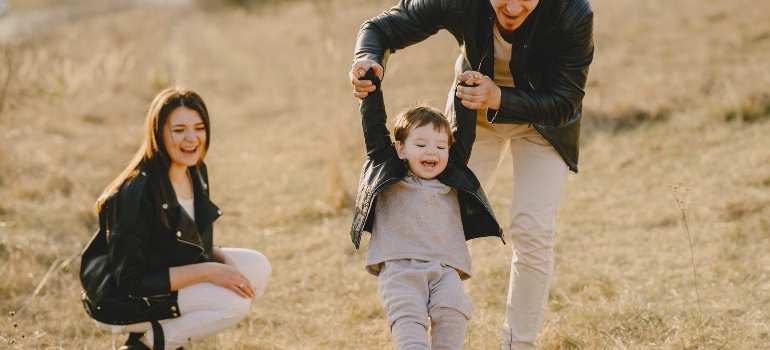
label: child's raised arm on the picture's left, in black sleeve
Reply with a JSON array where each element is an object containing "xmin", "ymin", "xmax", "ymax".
[{"xmin": 360, "ymin": 69, "xmax": 395, "ymax": 158}]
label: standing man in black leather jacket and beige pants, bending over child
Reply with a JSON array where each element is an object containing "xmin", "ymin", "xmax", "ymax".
[{"xmin": 350, "ymin": 0, "xmax": 594, "ymax": 349}]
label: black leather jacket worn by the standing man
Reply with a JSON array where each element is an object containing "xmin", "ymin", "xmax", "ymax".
[{"xmin": 355, "ymin": 0, "xmax": 594, "ymax": 172}]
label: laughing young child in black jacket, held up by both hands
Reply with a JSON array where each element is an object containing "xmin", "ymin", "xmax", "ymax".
[{"xmin": 351, "ymin": 67, "xmax": 502, "ymax": 350}]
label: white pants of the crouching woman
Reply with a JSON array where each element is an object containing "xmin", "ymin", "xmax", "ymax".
[{"xmin": 97, "ymin": 248, "xmax": 272, "ymax": 349}]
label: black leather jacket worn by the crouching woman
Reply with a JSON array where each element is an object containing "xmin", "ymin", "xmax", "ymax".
[{"xmin": 80, "ymin": 164, "xmax": 222, "ymax": 324}]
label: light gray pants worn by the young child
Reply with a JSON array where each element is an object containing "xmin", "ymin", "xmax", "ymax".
[{"xmin": 378, "ymin": 259, "xmax": 473, "ymax": 350}]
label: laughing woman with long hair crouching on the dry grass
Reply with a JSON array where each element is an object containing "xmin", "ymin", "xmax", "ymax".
[{"xmin": 81, "ymin": 87, "xmax": 271, "ymax": 350}]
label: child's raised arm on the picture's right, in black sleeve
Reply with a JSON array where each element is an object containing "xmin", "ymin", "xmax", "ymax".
[{"xmin": 448, "ymin": 72, "xmax": 481, "ymax": 164}]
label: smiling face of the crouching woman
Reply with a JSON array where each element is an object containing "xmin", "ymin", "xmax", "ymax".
[{"xmin": 163, "ymin": 106, "xmax": 206, "ymax": 172}]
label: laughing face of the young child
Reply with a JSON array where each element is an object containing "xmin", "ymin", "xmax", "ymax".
[{"xmin": 396, "ymin": 123, "xmax": 449, "ymax": 179}]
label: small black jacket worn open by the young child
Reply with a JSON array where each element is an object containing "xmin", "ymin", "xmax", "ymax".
[{"xmin": 350, "ymin": 70, "xmax": 505, "ymax": 249}]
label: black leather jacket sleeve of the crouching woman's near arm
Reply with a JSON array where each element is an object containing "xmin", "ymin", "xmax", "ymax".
[{"xmin": 108, "ymin": 180, "xmax": 171, "ymax": 297}]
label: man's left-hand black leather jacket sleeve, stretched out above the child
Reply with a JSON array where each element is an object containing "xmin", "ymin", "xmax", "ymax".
[{"xmin": 355, "ymin": 0, "xmax": 454, "ymax": 68}]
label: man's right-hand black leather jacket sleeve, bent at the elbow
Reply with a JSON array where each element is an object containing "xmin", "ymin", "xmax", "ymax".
[{"xmin": 488, "ymin": 2, "xmax": 594, "ymax": 126}]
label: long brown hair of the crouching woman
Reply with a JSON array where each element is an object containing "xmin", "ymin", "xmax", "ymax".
[{"xmin": 96, "ymin": 86, "xmax": 211, "ymax": 227}]
